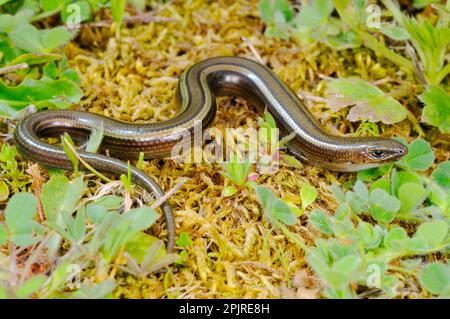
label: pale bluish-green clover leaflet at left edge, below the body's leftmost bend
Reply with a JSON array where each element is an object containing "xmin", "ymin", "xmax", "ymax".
[{"xmin": 5, "ymin": 193, "xmax": 39, "ymax": 246}]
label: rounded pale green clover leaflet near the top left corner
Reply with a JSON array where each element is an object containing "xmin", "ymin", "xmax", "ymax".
[{"xmin": 9, "ymin": 24, "xmax": 45, "ymax": 53}]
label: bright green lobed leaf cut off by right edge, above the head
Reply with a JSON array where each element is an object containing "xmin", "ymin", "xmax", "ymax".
[{"xmin": 419, "ymin": 85, "xmax": 450, "ymax": 133}]
